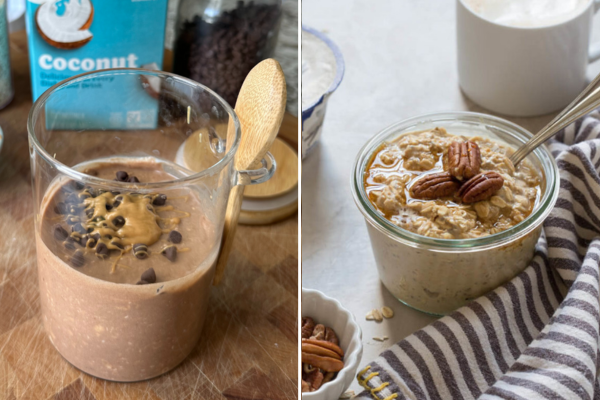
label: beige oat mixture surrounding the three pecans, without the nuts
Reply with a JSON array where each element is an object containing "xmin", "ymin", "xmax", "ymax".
[{"xmin": 364, "ymin": 128, "xmax": 543, "ymax": 239}]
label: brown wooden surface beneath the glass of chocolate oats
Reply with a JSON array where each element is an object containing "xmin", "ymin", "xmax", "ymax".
[{"xmin": 0, "ymin": 32, "xmax": 298, "ymax": 400}]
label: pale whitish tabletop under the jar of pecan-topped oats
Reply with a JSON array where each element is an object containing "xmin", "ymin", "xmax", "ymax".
[{"xmin": 302, "ymin": 0, "xmax": 600, "ymax": 393}]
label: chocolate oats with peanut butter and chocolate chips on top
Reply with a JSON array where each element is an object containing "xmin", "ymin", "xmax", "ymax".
[{"xmin": 37, "ymin": 159, "xmax": 220, "ymax": 381}]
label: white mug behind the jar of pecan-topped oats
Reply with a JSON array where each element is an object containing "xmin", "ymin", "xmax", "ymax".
[{"xmin": 456, "ymin": 0, "xmax": 600, "ymax": 116}]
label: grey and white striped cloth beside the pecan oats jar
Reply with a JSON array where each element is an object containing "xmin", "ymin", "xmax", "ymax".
[{"xmin": 357, "ymin": 111, "xmax": 600, "ymax": 400}]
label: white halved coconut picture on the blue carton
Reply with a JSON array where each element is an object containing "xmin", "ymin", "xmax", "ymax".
[{"xmin": 35, "ymin": 0, "xmax": 94, "ymax": 49}]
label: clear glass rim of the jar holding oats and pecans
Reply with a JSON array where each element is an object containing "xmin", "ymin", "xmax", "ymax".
[{"xmin": 351, "ymin": 111, "xmax": 560, "ymax": 252}]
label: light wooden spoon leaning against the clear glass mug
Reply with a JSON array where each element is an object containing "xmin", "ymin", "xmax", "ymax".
[{"xmin": 213, "ymin": 58, "xmax": 287, "ymax": 285}]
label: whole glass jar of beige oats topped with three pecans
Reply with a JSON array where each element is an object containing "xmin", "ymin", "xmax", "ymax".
[{"xmin": 352, "ymin": 112, "xmax": 559, "ymax": 315}]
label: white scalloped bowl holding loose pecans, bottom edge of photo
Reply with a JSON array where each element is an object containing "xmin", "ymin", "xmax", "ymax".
[{"xmin": 302, "ymin": 288, "xmax": 362, "ymax": 400}]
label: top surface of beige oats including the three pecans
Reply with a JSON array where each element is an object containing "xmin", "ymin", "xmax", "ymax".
[{"xmin": 365, "ymin": 128, "xmax": 543, "ymax": 239}]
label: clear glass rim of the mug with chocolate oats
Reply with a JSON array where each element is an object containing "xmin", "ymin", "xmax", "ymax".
[{"xmin": 27, "ymin": 68, "xmax": 241, "ymax": 190}]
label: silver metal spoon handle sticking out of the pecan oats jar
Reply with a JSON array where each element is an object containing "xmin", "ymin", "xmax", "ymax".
[{"xmin": 510, "ymin": 75, "xmax": 600, "ymax": 166}]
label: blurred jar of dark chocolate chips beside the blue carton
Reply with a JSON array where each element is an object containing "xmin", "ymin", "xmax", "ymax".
[{"xmin": 173, "ymin": 0, "xmax": 281, "ymax": 106}]
